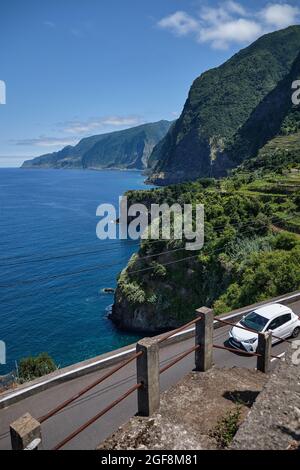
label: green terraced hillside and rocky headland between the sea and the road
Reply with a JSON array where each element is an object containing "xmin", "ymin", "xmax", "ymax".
[{"xmin": 112, "ymin": 133, "xmax": 300, "ymax": 332}]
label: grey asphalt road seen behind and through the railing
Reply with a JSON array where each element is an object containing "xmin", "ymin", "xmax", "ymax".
[{"xmin": 0, "ymin": 301, "xmax": 300, "ymax": 450}]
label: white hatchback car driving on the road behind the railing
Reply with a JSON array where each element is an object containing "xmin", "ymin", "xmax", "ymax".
[{"xmin": 229, "ymin": 304, "xmax": 300, "ymax": 352}]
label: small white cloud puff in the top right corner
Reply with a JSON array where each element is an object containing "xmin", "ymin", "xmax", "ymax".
[{"xmin": 261, "ymin": 3, "xmax": 300, "ymax": 28}]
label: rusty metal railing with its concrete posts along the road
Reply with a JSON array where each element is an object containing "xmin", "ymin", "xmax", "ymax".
[{"xmin": 10, "ymin": 307, "xmax": 290, "ymax": 450}]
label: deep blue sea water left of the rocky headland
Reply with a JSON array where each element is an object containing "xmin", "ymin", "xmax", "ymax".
[{"xmin": 0, "ymin": 169, "xmax": 145, "ymax": 375}]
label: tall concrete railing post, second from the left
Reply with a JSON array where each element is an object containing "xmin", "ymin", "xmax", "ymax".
[{"xmin": 136, "ymin": 338, "xmax": 160, "ymax": 416}]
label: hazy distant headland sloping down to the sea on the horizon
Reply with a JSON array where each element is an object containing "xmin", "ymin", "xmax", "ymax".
[{"xmin": 22, "ymin": 121, "xmax": 172, "ymax": 170}]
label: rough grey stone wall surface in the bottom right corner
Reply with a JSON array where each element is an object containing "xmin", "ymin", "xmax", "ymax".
[{"xmin": 231, "ymin": 346, "xmax": 300, "ymax": 450}]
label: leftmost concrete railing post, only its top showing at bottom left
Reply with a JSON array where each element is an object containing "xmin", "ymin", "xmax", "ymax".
[{"xmin": 10, "ymin": 413, "xmax": 42, "ymax": 450}]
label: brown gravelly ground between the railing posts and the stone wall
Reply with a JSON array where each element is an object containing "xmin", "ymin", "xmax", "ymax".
[{"xmin": 98, "ymin": 368, "xmax": 267, "ymax": 450}]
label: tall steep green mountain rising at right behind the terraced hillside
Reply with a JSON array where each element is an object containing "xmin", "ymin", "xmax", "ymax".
[{"xmin": 149, "ymin": 26, "xmax": 300, "ymax": 184}]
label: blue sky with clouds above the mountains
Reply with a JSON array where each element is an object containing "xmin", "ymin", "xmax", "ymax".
[{"xmin": 0, "ymin": 0, "xmax": 300, "ymax": 167}]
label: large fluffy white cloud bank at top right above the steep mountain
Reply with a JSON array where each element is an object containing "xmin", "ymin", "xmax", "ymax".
[{"xmin": 158, "ymin": 0, "xmax": 300, "ymax": 49}]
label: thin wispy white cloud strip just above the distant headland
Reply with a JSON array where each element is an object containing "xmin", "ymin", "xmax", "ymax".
[{"xmin": 59, "ymin": 116, "xmax": 145, "ymax": 134}]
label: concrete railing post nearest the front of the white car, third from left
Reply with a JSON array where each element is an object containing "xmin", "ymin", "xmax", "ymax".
[{"xmin": 195, "ymin": 307, "xmax": 214, "ymax": 372}]
